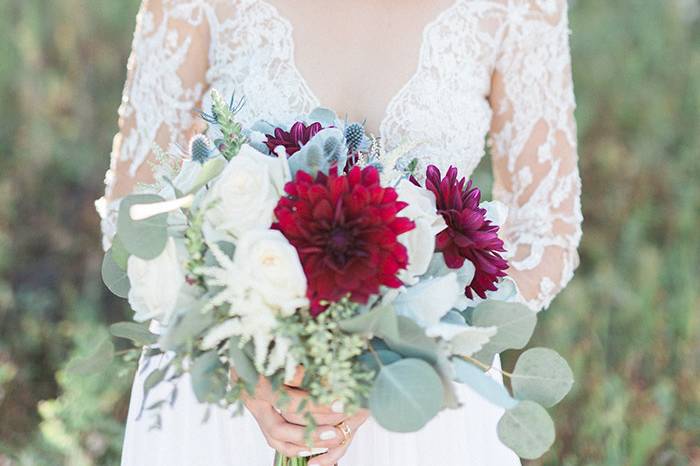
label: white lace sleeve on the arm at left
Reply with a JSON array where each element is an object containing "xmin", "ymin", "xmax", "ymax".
[{"xmin": 96, "ymin": 0, "xmax": 210, "ymax": 248}]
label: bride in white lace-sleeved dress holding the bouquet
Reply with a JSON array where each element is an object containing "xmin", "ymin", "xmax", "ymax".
[{"xmin": 98, "ymin": 0, "xmax": 581, "ymax": 466}]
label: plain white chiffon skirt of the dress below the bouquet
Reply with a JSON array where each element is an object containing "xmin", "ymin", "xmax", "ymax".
[{"xmin": 122, "ymin": 357, "xmax": 520, "ymax": 466}]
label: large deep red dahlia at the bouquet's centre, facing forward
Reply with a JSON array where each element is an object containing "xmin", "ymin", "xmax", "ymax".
[{"xmin": 275, "ymin": 166, "xmax": 414, "ymax": 315}]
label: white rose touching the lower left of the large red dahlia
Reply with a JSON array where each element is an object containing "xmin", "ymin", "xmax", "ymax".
[{"xmin": 233, "ymin": 230, "xmax": 308, "ymax": 315}]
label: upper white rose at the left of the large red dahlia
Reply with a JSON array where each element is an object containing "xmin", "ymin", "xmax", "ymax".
[{"xmin": 205, "ymin": 144, "xmax": 290, "ymax": 238}]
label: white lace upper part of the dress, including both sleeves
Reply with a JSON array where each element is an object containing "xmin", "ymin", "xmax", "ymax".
[{"xmin": 98, "ymin": 0, "xmax": 582, "ymax": 309}]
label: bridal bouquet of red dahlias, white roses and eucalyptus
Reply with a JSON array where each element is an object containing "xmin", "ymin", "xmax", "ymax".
[{"xmin": 97, "ymin": 92, "xmax": 573, "ymax": 464}]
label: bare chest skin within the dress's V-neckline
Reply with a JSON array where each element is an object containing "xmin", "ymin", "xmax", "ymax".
[{"xmin": 268, "ymin": 0, "xmax": 454, "ymax": 132}]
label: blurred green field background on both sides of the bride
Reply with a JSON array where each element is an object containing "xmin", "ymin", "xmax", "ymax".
[{"xmin": 0, "ymin": 0, "xmax": 700, "ymax": 466}]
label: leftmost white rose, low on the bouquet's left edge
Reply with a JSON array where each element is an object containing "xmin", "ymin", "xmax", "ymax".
[{"xmin": 127, "ymin": 238, "xmax": 185, "ymax": 325}]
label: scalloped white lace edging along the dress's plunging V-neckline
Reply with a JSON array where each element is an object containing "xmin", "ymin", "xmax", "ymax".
[{"xmin": 257, "ymin": 0, "xmax": 464, "ymax": 139}]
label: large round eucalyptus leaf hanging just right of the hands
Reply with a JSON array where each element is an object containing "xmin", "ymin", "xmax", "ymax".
[{"xmin": 369, "ymin": 359, "xmax": 444, "ymax": 432}]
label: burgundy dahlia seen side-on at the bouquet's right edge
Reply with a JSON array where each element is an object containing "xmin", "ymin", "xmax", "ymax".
[{"xmin": 425, "ymin": 165, "xmax": 508, "ymax": 298}]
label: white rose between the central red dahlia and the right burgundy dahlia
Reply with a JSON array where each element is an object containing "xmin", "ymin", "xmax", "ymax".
[{"xmin": 396, "ymin": 179, "xmax": 446, "ymax": 285}]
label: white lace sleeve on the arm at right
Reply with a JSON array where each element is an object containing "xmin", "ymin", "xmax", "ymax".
[{"xmin": 490, "ymin": 0, "xmax": 582, "ymax": 310}]
